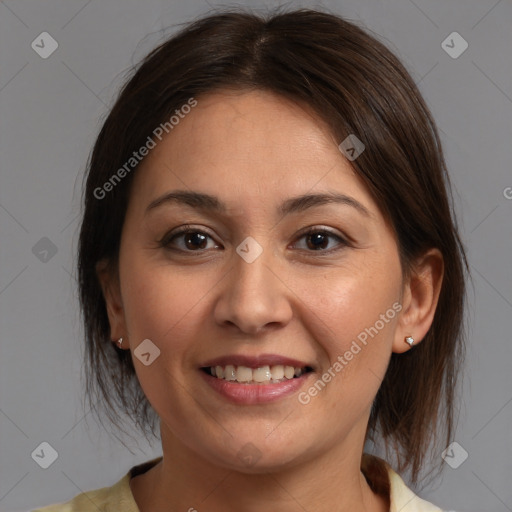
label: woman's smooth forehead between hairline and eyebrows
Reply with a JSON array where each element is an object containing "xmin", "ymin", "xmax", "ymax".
[{"xmin": 128, "ymin": 90, "xmax": 374, "ymax": 218}]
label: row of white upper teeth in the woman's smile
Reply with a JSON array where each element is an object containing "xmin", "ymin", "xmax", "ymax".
[{"xmin": 210, "ymin": 364, "xmax": 304, "ymax": 384}]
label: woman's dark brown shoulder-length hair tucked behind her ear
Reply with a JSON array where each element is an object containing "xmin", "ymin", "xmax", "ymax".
[{"xmin": 78, "ymin": 9, "xmax": 468, "ymax": 482}]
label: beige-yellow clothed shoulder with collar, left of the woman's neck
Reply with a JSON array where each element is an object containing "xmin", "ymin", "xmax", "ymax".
[{"xmin": 32, "ymin": 457, "xmax": 161, "ymax": 512}]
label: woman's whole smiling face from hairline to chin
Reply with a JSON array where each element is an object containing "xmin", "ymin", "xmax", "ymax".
[{"xmin": 105, "ymin": 91, "xmax": 404, "ymax": 472}]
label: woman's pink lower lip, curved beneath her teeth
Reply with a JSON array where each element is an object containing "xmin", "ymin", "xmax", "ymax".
[{"xmin": 199, "ymin": 370, "xmax": 313, "ymax": 404}]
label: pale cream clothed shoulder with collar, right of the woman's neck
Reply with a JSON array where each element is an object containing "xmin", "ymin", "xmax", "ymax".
[{"xmin": 362, "ymin": 453, "xmax": 443, "ymax": 512}]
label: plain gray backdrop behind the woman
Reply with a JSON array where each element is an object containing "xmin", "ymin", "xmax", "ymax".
[{"xmin": 0, "ymin": 0, "xmax": 512, "ymax": 512}]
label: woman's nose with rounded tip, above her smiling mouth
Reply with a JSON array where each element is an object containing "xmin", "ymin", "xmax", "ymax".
[{"xmin": 214, "ymin": 245, "xmax": 293, "ymax": 334}]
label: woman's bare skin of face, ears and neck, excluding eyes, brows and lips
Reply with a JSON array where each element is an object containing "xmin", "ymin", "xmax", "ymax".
[{"xmin": 98, "ymin": 91, "xmax": 443, "ymax": 512}]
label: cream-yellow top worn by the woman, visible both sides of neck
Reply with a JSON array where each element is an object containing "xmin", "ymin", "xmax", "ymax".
[{"xmin": 32, "ymin": 454, "xmax": 442, "ymax": 512}]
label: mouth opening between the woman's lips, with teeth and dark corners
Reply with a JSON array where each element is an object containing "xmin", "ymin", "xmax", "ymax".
[{"xmin": 201, "ymin": 364, "xmax": 313, "ymax": 385}]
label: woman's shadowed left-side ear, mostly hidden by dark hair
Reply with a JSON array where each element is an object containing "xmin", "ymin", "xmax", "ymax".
[{"xmin": 96, "ymin": 260, "xmax": 126, "ymax": 346}]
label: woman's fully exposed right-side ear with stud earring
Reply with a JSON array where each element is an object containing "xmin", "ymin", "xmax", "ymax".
[{"xmin": 393, "ymin": 249, "xmax": 444, "ymax": 354}]
